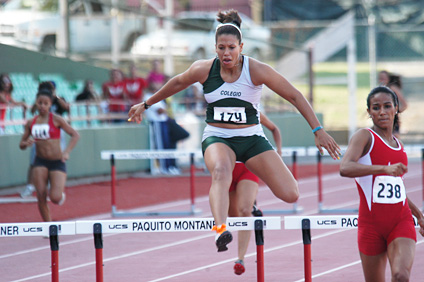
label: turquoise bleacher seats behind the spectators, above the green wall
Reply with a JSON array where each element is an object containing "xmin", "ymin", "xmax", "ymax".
[{"xmin": 0, "ymin": 73, "xmax": 204, "ymax": 134}]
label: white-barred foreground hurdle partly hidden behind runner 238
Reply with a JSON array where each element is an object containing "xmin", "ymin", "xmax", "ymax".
[{"xmin": 284, "ymin": 215, "xmax": 420, "ymax": 282}]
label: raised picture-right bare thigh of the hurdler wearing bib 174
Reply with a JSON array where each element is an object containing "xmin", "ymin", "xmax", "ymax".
[{"xmin": 246, "ymin": 151, "xmax": 297, "ymax": 198}]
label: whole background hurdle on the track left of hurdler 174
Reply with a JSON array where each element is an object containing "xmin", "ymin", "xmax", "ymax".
[{"xmin": 100, "ymin": 150, "xmax": 203, "ymax": 217}]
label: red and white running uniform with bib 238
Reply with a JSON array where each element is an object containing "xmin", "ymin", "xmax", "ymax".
[{"xmin": 355, "ymin": 129, "xmax": 417, "ymax": 256}]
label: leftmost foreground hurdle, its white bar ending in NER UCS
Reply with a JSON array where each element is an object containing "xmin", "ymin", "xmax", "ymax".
[{"xmin": 0, "ymin": 222, "xmax": 76, "ymax": 282}]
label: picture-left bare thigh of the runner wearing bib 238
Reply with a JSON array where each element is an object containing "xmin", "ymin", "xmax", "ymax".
[{"xmin": 359, "ymin": 252, "xmax": 387, "ymax": 282}]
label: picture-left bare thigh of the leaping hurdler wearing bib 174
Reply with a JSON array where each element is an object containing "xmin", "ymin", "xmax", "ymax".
[{"xmin": 204, "ymin": 142, "xmax": 236, "ymax": 175}]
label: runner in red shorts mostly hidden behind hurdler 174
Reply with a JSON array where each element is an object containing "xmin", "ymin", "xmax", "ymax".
[{"xmin": 228, "ymin": 113, "xmax": 282, "ymax": 275}]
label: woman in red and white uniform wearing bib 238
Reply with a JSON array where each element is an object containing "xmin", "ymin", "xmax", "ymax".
[{"xmin": 340, "ymin": 86, "xmax": 424, "ymax": 282}]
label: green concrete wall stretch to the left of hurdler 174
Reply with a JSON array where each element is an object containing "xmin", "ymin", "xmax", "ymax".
[{"xmin": 0, "ymin": 125, "xmax": 149, "ymax": 188}]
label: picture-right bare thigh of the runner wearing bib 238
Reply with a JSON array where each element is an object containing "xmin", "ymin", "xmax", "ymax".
[{"xmin": 387, "ymin": 238, "xmax": 415, "ymax": 278}]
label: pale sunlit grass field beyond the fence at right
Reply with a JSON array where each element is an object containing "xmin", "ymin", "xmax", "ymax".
[{"xmin": 293, "ymin": 62, "xmax": 424, "ymax": 133}]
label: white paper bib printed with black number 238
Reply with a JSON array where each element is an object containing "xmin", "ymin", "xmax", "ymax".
[{"xmin": 373, "ymin": 175, "xmax": 406, "ymax": 204}]
